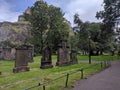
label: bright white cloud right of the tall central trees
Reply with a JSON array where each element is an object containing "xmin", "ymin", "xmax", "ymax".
[{"xmin": 65, "ymin": 0, "xmax": 103, "ymax": 25}]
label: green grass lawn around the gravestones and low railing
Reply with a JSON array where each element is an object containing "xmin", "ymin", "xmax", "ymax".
[{"xmin": 0, "ymin": 56, "xmax": 116, "ymax": 90}]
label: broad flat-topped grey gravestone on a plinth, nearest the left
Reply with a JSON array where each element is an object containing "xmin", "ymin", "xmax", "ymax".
[{"xmin": 13, "ymin": 45, "xmax": 29, "ymax": 73}]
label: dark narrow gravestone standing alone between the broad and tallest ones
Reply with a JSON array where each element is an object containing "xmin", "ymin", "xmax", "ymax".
[{"xmin": 40, "ymin": 47, "xmax": 53, "ymax": 69}]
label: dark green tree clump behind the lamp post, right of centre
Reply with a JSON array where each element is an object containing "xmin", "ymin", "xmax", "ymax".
[{"xmin": 74, "ymin": 14, "xmax": 105, "ymax": 55}]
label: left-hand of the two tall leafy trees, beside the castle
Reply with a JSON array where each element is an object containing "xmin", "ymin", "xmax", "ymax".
[{"xmin": 26, "ymin": 0, "xmax": 50, "ymax": 53}]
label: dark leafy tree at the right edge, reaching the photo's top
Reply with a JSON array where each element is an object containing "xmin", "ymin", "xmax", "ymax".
[{"xmin": 96, "ymin": 0, "xmax": 120, "ymax": 54}]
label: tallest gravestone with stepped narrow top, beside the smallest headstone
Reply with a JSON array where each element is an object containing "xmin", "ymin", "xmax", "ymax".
[{"xmin": 56, "ymin": 40, "xmax": 70, "ymax": 66}]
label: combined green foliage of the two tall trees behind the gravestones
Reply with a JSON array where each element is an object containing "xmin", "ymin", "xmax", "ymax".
[{"xmin": 25, "ymin": 0, "xmax": 69, "ymax": 53}]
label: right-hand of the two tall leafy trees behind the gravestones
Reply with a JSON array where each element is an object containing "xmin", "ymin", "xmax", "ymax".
[{"xmin": 48, "ymin": 5, "xmax": 69, "ymax": 51}]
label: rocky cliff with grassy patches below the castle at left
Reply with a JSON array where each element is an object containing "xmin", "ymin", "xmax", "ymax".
[{"xmin": 0, "ymin": 22, "xmax": 29, "ymax": 46}]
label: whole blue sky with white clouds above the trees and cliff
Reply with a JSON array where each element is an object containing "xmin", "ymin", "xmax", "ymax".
[{"xmin": 0, "ymin": 0, "xmax": 103, "ymax": 25}]
